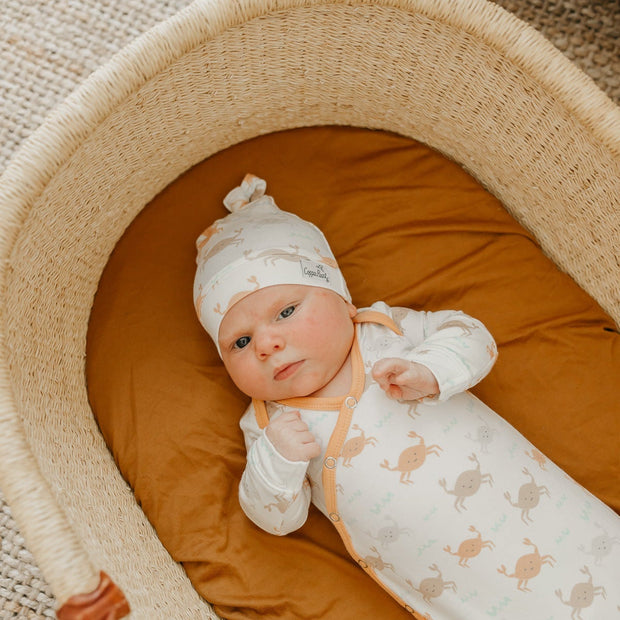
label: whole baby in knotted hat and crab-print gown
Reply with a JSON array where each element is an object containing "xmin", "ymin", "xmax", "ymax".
[{"xmin": 194, "ymin": 175, "xmax": 620, "ymax": 620}]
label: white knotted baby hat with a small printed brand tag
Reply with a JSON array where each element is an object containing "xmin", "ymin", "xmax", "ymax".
[{"xmin": 194, "ymin": 174, "xmax": 351, "ymax": 352}]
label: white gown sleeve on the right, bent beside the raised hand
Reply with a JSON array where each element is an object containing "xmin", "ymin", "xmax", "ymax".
[{"xmin": 391, "ymin": 308, "xmax": 497, "ymax": 402}]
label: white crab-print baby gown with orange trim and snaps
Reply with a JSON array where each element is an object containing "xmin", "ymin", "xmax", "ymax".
[{"xmin": 239, "ymin": 302, "xmax": 620, "ymax": 620}]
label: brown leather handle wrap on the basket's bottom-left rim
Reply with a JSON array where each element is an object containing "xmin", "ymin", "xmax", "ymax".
[{"xmin": 56, "ymin": 571, "xmax": 130, "ymax": 620}]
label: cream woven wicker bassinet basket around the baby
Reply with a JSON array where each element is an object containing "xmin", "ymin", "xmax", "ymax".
[{"xmin": 0, "ymin": 0, "xmax": 620, "ymax": 619}]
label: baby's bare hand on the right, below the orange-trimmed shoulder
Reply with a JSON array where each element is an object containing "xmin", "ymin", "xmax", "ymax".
[{"xmin": 372, "ymin": 357, "xmax": 439, "ymax": 400}]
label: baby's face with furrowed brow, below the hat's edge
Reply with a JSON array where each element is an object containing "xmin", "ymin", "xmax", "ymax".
[{"xmin": 219, "ymin": 284, "xmax": 356, "ymax": 400}]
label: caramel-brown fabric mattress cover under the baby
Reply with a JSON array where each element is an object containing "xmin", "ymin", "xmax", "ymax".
[{"xmin": 87, "ymin": 127, "xmax": 620, "ymax": 620}]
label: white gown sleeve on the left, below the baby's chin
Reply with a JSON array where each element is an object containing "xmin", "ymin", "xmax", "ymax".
[{"xmin": 239, "ymin": 405, "xmax": 311, "ymax": 536}]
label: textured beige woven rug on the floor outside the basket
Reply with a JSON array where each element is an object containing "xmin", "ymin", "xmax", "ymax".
[{"xmin": 0, "ymin": 0, "xmax": 620, "ymax": 620}]
